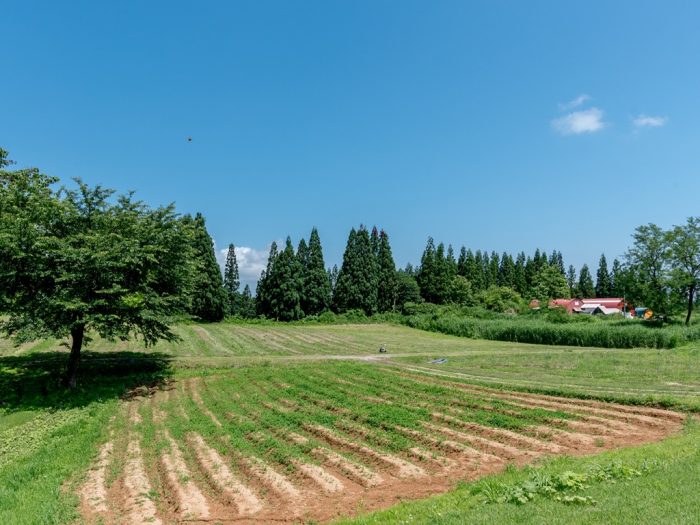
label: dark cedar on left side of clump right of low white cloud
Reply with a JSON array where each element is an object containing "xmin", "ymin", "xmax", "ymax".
[{"xmin": 267, "ymin": 237, "xmax": 302, "ymax": 321}]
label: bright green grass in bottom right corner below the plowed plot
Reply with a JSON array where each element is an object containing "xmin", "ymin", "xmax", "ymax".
[{"xmin": 338, "ymin": 423, "xmax": 700, "ymax": 525}]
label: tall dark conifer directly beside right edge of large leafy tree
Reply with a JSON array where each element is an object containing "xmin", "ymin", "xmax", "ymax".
[{"xmin": 184, "ymin": 213, "xmax": 227, "ymax": 322}]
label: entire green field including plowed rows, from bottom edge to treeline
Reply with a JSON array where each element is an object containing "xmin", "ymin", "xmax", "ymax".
[{"xmin": 0, "ymin": 323, "xmax": 700, "ymax": 523}]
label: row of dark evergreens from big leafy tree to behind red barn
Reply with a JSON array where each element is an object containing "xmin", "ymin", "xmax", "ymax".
[{"xmin": 183, "ymin": 214, "xmax": 631, "ymax": 321}]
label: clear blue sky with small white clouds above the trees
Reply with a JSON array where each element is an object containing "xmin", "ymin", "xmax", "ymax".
[{"xmin": 0, "ymin": 0, "xmax": 700, "ymax": 288}]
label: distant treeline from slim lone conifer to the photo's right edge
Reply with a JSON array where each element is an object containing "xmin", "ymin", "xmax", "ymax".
[{"xmin": 215, "ymin": 217, "xmax": 700, "ymax": 322}]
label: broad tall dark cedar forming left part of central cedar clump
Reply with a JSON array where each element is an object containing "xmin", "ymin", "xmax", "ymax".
[{"xmin": 333, "ymin": 226, "xmax": 377, "ymax": 315}]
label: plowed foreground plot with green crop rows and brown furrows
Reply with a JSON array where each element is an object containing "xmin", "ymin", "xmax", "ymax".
[{"xmin": 79, "ymin": 362, "xmax": 685, "ymax": 524}]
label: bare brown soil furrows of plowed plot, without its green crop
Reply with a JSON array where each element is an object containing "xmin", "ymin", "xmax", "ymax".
[{"xmin": 79, "ymin": 372, "xmax": 685, "ymax": 524}]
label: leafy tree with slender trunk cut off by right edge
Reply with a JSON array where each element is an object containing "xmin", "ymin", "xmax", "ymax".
[{"xmin": 667, "ymin": 217, "xmax": 700, "ymax": 324}]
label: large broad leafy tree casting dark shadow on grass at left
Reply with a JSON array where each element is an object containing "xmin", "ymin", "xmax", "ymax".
[{"xmin": 0, "ymin": 151, "xmax": 191, "ymax": 387}]
